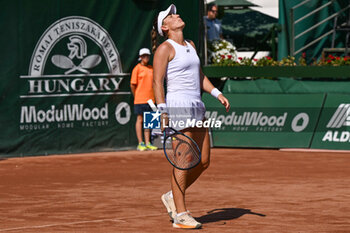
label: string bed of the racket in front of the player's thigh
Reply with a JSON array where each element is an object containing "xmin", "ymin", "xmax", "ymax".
[{"xmin": 167, "ymin": 134, "xmax": 200, "ymax": 169}]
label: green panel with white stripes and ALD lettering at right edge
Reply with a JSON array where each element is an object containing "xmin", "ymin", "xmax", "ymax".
[{"xmin": 311, "ymin": 94, "xmax": 350, "ymax": 150}]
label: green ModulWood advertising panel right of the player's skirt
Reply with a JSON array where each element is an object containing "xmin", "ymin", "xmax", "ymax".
[{"xmin": 203, "ymin": 94, "xmax": 324, "ymax": 148}]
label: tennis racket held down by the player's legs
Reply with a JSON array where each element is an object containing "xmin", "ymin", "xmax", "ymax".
[{"xmin": 147, "ymin": 100, "xmax": 201, "ymax": 170}]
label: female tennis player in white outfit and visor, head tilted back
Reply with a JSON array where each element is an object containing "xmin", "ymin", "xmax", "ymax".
[{"xmin": 152, "ymin": 4, "xmax": 230, "ymax": 228}]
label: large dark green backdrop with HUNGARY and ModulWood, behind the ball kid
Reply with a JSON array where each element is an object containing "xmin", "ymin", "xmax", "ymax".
[{"xmin": 0, "ymin": 0, "xmax": 201, "ymax": 157}]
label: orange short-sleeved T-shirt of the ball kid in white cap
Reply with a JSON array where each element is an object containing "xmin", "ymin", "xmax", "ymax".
[{"xmin": 130, "ymin": 63, "xmax": 155, "ymax": 104}]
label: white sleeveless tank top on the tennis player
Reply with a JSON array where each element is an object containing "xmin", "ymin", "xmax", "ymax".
[{"xmin": 166, "ymin": 39, "xmax": 201, "ymax": 99}]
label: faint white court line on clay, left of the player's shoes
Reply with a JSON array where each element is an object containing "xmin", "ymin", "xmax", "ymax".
[{"xmin": 0, "ymin": 213, "xmax": 163, "ymax": 232}]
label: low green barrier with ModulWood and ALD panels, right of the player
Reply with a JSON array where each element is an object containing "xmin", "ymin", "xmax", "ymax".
[{"xmin": 203, "ymin": 94, "xmax": 350, "ymax": 150}]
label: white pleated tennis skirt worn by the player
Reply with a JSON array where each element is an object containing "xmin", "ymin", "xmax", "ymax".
[{"xmin": 166, "ymin": 95, "xmax": 205, "ymax": 130}]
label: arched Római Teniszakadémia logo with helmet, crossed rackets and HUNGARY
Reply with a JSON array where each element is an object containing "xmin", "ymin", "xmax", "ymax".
[{"xmin": 20, "ymin": 16, "xmax": 130, "ymax": 98}]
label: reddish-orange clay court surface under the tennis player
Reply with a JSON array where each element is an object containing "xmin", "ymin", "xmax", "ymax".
[{"xmin": 0, "ymin": 149, "xmax": 350, "ymax": 233}]
